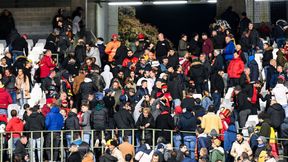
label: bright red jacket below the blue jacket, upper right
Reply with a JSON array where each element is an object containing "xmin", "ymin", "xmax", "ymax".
[{"xmin": 227, "ymin": 57, "xmax": 244, "ymax": 79}]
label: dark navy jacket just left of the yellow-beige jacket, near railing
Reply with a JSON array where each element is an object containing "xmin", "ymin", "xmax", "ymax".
[{"xmin": 178, "ymin": 111, "xmax": 197, "ymax": 136}]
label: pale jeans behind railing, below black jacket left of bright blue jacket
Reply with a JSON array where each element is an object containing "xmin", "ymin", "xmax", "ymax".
[{"xmin": 30, "ymin": 138, "xmax": 43, "ymax": 162}]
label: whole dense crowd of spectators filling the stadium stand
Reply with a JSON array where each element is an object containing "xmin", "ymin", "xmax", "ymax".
[{"xmin": 0, "ymin": 5, "xmax": 288, "ymax": 162}]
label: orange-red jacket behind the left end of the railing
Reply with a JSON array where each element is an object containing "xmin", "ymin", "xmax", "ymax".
[{"xmin": 6, "ymin": 117, "xmax": 24, "ymax": 138}]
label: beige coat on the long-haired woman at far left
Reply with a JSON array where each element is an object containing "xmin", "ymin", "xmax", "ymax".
[{"xmin": 15, "ymin": 76, "xmax": 31, "ymax": 99}]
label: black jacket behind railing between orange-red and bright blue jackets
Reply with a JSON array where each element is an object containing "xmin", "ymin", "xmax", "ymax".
[{"xmin": 25, "ymin": 112, "xmax": 45, "ymax": 139}]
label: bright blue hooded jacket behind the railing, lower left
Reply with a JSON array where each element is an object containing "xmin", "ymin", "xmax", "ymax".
[{"xmin": 45, "ymin": 106, "xmax": 64, "ymax": 130}]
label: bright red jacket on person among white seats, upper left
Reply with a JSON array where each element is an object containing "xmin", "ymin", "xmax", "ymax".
[{"xmin": 40, "ymin": 55, "xmax": 56, "ymax": 78}]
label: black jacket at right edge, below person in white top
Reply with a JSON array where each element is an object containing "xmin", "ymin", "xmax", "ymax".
[{"xmin": 267, "ymin": 103, "xmax": 285, "ymax": 129}]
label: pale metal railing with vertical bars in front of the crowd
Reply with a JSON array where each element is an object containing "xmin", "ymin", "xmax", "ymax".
[{"xmin": 0, "ymin": 129, "xmax": 288, "ymax": 162}]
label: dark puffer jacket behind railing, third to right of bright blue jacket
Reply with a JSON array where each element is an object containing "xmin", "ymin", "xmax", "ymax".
[{"xmin": 90, "ymin": 101, "xmax": 108, "ymax": 130}]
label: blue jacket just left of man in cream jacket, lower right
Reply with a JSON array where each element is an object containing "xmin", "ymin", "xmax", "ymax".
[{"xmin": 224, "ymin": 124, "xmax": 237, "ymax": 152}]
